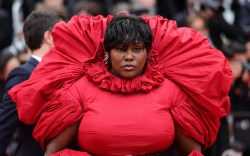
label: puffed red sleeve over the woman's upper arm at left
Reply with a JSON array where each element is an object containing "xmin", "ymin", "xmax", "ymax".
[{"xmin": 33, "ymin": 90, "xmax": 83, "ymax": 150}]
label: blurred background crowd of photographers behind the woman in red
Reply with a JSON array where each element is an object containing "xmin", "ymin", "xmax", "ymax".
[{"xmin": 0, "ymin": 0, "xmax": 250, "ymax": 156}]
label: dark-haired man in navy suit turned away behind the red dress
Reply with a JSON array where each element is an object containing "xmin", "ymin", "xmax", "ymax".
[{"xmin": 0, "ymin": 11, "xmax": 65, "ymax": 156}]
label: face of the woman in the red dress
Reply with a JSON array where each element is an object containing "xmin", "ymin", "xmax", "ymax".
[{"xmin": 110, "ymin": 43, "xmax": 147, "ymax": 79}]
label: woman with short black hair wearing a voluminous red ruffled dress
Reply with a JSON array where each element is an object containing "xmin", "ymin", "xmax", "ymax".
[{"xmin": 9, "ymin": 15, "xmax": 232, "ymax": 156}]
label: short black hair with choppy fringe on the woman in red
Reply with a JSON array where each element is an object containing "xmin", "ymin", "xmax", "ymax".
[{"xmin": 104, "ymin": 15, "xmax": 153, "ymax": 52}]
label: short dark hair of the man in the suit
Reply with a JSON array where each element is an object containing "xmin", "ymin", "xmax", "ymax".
[{"xmin": 23, "ymin": 11, "xmax": 66, "ymax": 51}]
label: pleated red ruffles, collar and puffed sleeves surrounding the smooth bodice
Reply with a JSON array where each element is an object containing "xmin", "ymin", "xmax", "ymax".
[{"xmin": 9, "ymin": 15, "xmax": 233, "ymax": 156}]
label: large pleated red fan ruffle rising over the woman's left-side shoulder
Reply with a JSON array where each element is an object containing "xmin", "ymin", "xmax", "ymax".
[{"xmin": 9, "ymin": 15, "xmax": 111, "ymax": 124}]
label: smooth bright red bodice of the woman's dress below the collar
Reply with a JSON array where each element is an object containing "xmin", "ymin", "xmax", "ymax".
[{"xmin": 70, "ymin": 77, "xmax": 186, "ymax": 156}]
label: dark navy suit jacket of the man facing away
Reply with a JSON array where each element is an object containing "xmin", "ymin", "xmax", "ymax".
[{"xmin": 0, "ymin": 57, "xmax": 44, "ymax": 156}]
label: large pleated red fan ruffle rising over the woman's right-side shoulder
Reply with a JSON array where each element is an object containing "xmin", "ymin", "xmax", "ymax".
[{"xmin": 144, "ymin": 16, "xmax": 233, "ymax": 118}]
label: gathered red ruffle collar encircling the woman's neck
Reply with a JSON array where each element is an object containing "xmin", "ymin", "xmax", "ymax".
[{"xmin": 84, "ymin": 50, "xmax": 164, "ymax": 93}]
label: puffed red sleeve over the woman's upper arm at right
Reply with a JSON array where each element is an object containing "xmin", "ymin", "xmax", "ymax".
[{"xmin": 170, "ymin": 94, "xmax": 220, "ymax": 150}]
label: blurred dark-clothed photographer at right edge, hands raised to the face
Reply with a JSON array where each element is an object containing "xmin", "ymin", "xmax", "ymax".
[{"xmin": 229, "ymin": 42, "xmax": 250, "ymax": 112}]
